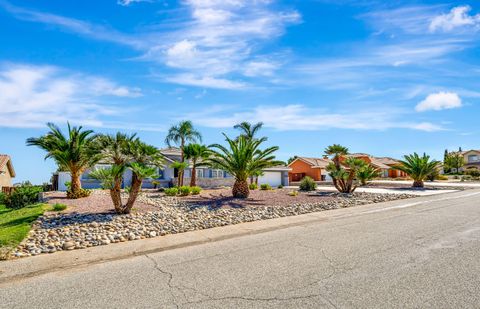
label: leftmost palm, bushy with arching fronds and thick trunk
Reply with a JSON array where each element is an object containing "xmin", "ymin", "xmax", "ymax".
[{"xmin": 27, "ymin": 123, "xmax": 100, "ymax": 198}]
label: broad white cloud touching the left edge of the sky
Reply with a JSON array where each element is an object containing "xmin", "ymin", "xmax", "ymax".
[{"xmin": 0, "ymin": 64, "xmax": 140, "ymax": 127}]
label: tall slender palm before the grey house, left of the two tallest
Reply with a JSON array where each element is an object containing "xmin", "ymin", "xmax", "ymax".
[{"xmin": 165, "ymin": 120, "xmax": 202, "ymax": 186}]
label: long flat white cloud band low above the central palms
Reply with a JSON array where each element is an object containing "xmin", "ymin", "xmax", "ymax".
[{"xmin": 187, "ymin": 104, "xmax": 444, "ymax": 132}]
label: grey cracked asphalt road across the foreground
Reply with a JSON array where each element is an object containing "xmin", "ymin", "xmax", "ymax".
[{"xmin": 0, "ymin": 190, "xmax": 480, "ymax": 308}]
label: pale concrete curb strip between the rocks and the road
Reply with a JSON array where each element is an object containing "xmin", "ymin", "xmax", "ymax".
[{"xmin": 0, "ymin": 190, "xmax": 480, "ymax": 285}]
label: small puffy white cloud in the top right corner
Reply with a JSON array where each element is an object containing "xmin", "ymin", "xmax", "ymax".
[{"xmin": 429, "ymin": 5, "xmax": 480, "ymax": 32}]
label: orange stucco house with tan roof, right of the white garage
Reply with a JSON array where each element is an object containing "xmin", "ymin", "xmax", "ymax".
[{"xmin": 288, "ymin": 157, "xmax": 331, "ymax": 182}]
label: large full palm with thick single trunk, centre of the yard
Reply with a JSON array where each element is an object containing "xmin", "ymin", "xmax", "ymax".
[{"xmin": 206, "ymin": 134, "xmax": 278, "ymax": 198}]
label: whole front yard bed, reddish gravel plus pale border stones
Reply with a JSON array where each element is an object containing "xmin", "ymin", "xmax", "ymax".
[{"xmin": 12, "ymin": 189, "xmax": 413, "ymax": 257}]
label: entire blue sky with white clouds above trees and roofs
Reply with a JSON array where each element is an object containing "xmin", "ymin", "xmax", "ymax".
[{"xmin": 0, "ymin": 0, "xmax": 480, "ymax": 183}]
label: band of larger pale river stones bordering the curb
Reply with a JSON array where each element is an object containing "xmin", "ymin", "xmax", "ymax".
[{"xmin": 12, "ymin": 193, "xmax": 413, "ymax": 257}]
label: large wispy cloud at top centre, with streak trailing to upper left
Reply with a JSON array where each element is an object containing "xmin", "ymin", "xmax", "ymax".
[{"xmin": 0, "ymin": 0, "xmax": 301, "ymax": 89}]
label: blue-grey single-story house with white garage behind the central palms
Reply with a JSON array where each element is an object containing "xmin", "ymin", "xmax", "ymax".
[{"xmin": 54, "ymin": 147, "xmax": 290, "ymax": 191}]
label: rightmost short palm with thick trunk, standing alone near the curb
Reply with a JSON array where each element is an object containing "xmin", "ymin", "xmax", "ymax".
[{"xmin": 395, "ymin": 152, "xmax": 440, "ymax": 188}]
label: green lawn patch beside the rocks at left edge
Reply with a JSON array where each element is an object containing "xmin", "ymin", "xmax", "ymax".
[{"xmin": 0, "ymin": 204, "xmax": 51, "ymax": 259}]
